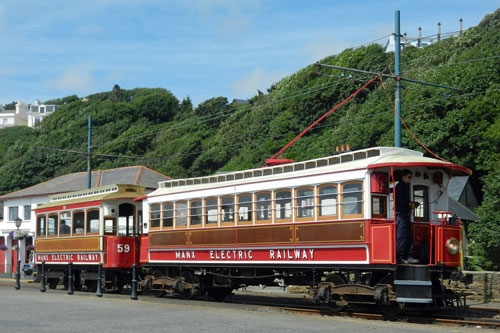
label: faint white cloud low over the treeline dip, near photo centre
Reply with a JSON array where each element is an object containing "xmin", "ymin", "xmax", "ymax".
[{"xmin": 231, "ymin": 68, "xmax": 286, "ymax": 98}]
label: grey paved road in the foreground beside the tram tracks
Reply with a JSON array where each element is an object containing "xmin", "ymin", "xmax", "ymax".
[{"xmin": 0, "ymin": 280, "xmax": 480, "ymax": 333}]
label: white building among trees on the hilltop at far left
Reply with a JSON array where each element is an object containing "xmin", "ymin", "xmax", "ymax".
[{"xmin": 0, "ymin": 100, "xmax": 58, "ymax": 128}]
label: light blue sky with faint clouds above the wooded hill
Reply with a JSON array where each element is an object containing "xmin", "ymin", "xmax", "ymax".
[{"xmin": 0, "ymin": 0, "xmax": 500, "ymax": 105}]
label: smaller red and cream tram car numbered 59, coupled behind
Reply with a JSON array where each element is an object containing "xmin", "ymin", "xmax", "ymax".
[{"xmin": 35, "ymin": 185, "xmax": 145, "ymax": 291}]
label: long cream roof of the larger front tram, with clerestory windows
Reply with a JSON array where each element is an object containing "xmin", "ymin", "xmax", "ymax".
[{"xmin": 148, "ymin": 147, "xmax": 472, "ymax": 196}]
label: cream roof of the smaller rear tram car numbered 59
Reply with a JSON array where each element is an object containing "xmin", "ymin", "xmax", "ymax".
[{"xmin": 36, "ymin": 184, "xmax": 145, "ymax": 210}]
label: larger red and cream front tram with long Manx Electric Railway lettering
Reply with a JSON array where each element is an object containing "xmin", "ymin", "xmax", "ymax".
[{"xmin": 140, "ymin": 147, "xmax": 471, "ymax": 312}]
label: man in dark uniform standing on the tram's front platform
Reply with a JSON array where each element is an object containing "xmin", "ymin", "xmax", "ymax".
[{"xmin": 396, "ymin": 169, "xmax": 419, "ymax": 264}]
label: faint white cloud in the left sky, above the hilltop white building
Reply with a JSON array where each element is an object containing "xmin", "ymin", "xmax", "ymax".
[{"xmin": 46, "ymin": 65, "xmax": 95, "ymax": 95}]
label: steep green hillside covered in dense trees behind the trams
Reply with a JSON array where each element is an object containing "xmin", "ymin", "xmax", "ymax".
[{"xmin": 0, "ymin": 11, "xmax": 500, "ymax": 269}]
